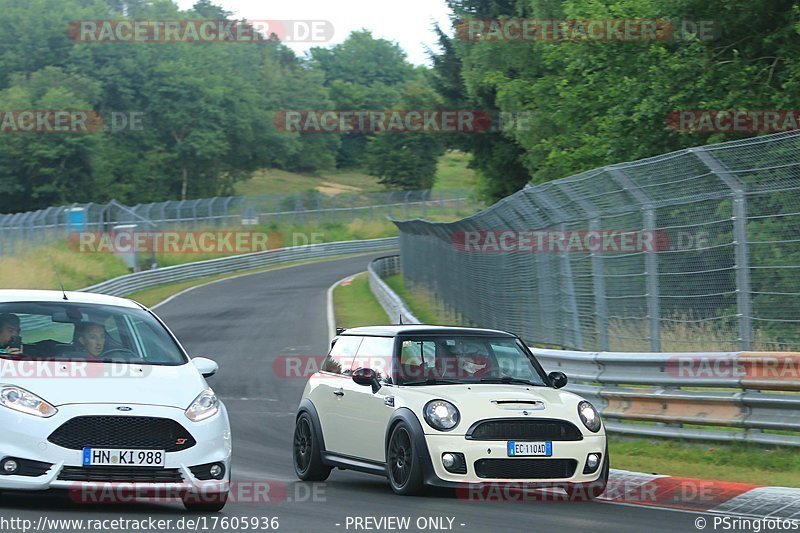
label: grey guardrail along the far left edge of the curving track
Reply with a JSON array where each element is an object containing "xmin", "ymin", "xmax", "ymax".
[{"xmin": 81, "ymin": 237, "xmax": 398, "ymax": 296}]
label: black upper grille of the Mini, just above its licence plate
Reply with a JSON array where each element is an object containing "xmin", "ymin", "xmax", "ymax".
[{"xmin": 467, "ymin": 418, "xmax": 583, "ymax": 441}]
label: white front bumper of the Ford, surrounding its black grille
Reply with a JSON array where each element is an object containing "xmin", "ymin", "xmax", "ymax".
[{"xmin": 0, "ymin": 404, "xmax": 231, "ymax": 499}]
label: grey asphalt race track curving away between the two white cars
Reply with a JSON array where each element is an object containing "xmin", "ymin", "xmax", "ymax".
[{"xmin": 0, "ymin": 256, "xmax": 712, "ymax": 533}]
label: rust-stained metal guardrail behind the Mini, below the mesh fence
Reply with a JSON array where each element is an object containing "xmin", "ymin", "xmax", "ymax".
[{"xmin": 369, "ymin": 256, "xmax": 800, "ymax": 446}]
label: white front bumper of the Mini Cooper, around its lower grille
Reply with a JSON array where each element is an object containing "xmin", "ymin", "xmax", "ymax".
[{"xmin": 425, "ymin": 433, "xmax": 607, "ymax": 487}]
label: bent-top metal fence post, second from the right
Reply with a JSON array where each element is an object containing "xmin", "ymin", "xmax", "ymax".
[{"xmin": 605, "ymin": 167, "xmax": 661, "ymax": 352}]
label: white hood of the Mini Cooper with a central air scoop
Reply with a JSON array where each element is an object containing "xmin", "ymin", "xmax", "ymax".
[{"xmin": 399, "ymin": 384, "xmax": 582, "ymax": 433}]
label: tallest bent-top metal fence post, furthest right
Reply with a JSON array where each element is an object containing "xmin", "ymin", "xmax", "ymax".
[{"xmin": 689, "ymin": 147, "xmax": 753, "ymax": 350}]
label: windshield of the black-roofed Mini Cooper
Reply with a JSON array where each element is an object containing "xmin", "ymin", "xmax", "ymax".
[{"xmin": 397, "ymin": 336, "xmax": 546, "ymax": 386}]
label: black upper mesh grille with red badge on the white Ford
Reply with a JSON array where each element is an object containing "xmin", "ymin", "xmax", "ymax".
[{"xmin": 47, "ymin": 416, "xmax": 197, "ymax": 452}]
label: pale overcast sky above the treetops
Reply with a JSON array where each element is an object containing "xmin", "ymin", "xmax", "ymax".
[{"xmin": 176, "ymin": 0, "xmax": 450, "ymax": 65}]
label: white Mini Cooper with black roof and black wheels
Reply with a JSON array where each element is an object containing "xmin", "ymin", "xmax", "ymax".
[{"xmin": 293, "ymin": 325, "xmax": 609, "ymax": 499}]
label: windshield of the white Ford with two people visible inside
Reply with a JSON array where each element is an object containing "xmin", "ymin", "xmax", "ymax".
[{"xmin": 0, "ymin": 302, "xmax": 187, "ymax": 365}]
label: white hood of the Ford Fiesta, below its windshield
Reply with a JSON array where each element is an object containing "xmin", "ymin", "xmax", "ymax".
[{"xmin": 0, "ymin": 359, "xmax": 208, "ymax": 409}]
